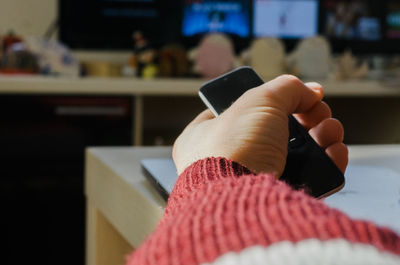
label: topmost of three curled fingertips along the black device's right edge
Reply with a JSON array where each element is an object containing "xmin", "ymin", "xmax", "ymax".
[{"xmin": 294, "ymin": 101, "xmax": 332, "ymax": 130}]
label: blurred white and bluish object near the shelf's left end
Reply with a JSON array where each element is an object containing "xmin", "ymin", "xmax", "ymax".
[{"xmin": 25, "ymin": 37, "xmax": 80, "ymax": 77}]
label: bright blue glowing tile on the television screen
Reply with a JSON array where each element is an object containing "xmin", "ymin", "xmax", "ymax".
[{"xmin": 182, "ymin": 0, "xmax": 250, "ymax": 38}]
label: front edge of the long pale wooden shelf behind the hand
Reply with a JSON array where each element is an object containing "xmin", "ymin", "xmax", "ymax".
[{"xmin": 0, "ymin": 75, "xmax": 400, "ymax": 97}]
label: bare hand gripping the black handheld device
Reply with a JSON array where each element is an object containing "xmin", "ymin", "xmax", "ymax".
[{"xmin": 172, "ymin": 75, "xmax": 348, "ymax": 177}]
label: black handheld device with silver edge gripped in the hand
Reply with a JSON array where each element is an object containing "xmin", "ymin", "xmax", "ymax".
[{"xmin": 199, "ymin": 66, "xmax": 345, "ymax": 198}]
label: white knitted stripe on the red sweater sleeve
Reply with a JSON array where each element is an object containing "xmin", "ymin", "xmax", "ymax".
[{"xmin": 203, "ymin": 239, "xmax": 400, "ymax": 265}]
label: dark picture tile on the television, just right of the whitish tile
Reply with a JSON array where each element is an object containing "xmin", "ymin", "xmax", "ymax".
[{"xmin": 323, "ymin": 0, "xmax": 382, "ymax": 41}]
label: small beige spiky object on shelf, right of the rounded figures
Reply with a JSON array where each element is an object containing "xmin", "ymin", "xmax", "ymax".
[{"xmin": 333, "ymin": 51, "xmax": 369, "ymax": 80}]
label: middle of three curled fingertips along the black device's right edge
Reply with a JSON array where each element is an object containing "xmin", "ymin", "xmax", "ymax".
[{"xmin": 308, "ymin": 118, "xmax": 344, "ymax": 148}]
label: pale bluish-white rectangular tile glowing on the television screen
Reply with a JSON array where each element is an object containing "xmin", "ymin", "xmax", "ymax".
[{"xmin": 253, "ymin": 0, "xmax": 318, "ymax": 38}]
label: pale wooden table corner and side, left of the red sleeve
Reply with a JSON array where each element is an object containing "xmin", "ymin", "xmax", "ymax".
[{"xmin": 85, "ymin": 147, "xmax": 171, "ymax": 265}]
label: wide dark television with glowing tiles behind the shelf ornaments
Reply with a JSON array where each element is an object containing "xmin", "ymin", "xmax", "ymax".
[{"xmin": 58, "ymin": 0, "xmax": 400, "ymax": 53}]
